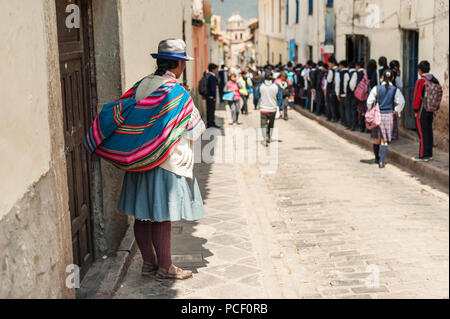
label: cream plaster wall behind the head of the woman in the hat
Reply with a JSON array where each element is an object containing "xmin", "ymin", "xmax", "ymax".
[{"xmin": 118, "ymin": 0, "xmax": 194, "ymax": 90}]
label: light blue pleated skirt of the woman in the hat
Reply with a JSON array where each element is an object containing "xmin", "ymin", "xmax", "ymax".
[{"xmin": 119, "ymin": 167, "xmax": 205, "ymax": 222}]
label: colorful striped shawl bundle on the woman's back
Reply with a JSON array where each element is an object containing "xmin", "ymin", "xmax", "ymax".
[{"xmin": 84, "ymin": 79, "xmax": 198, "ymax": 172}]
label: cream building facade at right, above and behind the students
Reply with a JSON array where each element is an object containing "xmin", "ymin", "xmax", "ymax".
[{"xmin": 334, "ymin": 0, "xmax": 449, "ymax": 150}]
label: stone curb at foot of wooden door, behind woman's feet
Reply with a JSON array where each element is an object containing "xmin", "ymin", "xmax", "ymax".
[{"xmin": 92, "ymin": 224, "xmax": 137, "ymax": 299}]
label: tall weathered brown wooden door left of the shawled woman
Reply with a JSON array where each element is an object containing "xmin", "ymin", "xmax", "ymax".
[{"xmin": 56, "ymin": 0, "xmax": 94, "ymax": 278}]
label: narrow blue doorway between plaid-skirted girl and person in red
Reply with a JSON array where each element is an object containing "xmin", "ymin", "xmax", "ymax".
[{"xmin": 402, "ymin": 30, "xmax": 419, "ymax": 129}]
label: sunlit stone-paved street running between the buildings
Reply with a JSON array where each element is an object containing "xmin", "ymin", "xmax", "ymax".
[{"xmin": 115, "ymin": 102, "xmax": 449, "ymax": 299}]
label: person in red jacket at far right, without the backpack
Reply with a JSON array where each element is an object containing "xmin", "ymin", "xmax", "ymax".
[{"xmin": 413, "ymin": 61, "xmax": 439, "ymax": 162}]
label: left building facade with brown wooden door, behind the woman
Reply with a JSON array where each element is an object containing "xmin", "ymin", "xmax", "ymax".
[{"xmin": 0, "ymin": 0, "xmax": 194, "ymax": 298}]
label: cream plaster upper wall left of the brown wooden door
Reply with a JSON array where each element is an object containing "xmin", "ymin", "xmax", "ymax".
[{"xmin": 0, "ymin": 0, "xmax": 50, "ymax": 219}]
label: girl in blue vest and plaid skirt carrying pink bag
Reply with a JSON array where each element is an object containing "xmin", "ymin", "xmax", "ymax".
[{"xmin": 367, "ymin": 70, "xmax": 405, "ymax": 168}]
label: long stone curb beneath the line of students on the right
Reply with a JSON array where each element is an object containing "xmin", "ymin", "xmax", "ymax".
[{"xmin": 295, "ymin": 105, "xmax": 449, "ymax": 192}]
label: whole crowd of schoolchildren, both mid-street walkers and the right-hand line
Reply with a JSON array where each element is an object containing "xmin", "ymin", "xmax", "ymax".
[{"xmin": 202, "ymin": 56, "xmax": 442, "ymax": 164}]
